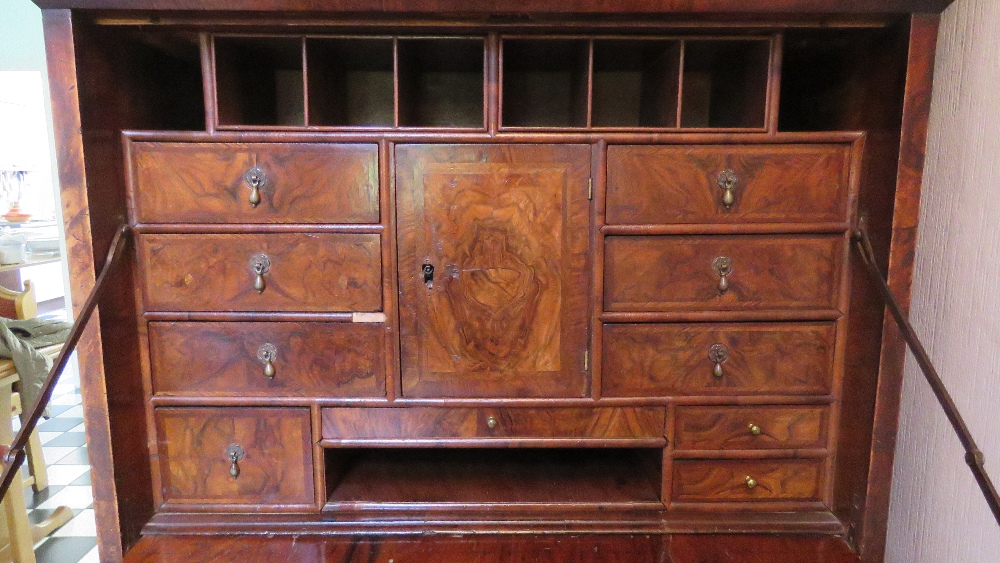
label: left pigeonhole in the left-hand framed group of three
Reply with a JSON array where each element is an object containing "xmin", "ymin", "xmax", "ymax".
[{"xmin": 214, "ymin": 36, "xmax": 306, "ymax": 126}]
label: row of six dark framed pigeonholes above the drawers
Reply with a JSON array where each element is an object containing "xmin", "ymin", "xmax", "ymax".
[{"xmin": 211, "ymin": 35, "xmax": 776, "ymax": 130}]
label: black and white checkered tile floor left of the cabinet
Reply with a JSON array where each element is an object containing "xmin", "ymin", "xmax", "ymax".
[{"xmin": 24, "ymin": 393, "xmax": 98, "ymax": 563}]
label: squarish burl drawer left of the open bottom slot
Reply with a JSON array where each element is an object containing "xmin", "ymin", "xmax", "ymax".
[{"xmin": 155, "ymin": 407, "xmax": 315, "ymax": 509}]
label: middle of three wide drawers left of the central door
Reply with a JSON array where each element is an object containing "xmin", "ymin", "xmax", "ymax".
[{"xmin": 143, "ymin": 233, "xmax": 382, "ymax": 312}]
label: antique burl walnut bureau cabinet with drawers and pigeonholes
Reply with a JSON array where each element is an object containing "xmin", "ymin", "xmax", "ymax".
[{"xmin": 31, "ymin": 0, "xmax": 945, "ymax": 561}]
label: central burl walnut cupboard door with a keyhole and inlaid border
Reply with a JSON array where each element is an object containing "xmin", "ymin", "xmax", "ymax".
[{"xmin": 396, "ymin": 145, "xmax": 590, "ymax": 397}]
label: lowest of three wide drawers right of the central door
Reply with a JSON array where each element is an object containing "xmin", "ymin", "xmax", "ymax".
[{"xmin": 602, "ymin": 322, "xmax": 836, "ymax": 397}]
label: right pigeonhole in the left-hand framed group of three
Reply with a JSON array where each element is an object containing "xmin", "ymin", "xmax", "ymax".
[{"xmin": 398, "ymin": 37, "xmax": 486, "ymax": 129}]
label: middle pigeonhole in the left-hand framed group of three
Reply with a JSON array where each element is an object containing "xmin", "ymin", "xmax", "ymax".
[{"xmin": 306, "ymin": 38, "xmax": 395, "ymax": 127}]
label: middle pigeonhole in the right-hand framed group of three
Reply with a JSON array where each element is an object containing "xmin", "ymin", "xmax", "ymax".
[{"xmin": 591, "ymin": 40, "xmax": 680, "ymax": 128}]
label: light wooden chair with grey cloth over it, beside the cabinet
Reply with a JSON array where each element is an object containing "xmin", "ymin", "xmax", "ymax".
[{"xmin": 0, "ymin": 280, "xmax": 73, "ymax": 563}]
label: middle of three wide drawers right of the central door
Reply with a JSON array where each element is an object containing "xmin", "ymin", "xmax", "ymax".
[{"xmin": 604, "ymin": 235, "xmax": 845, "ymax": 311}]
